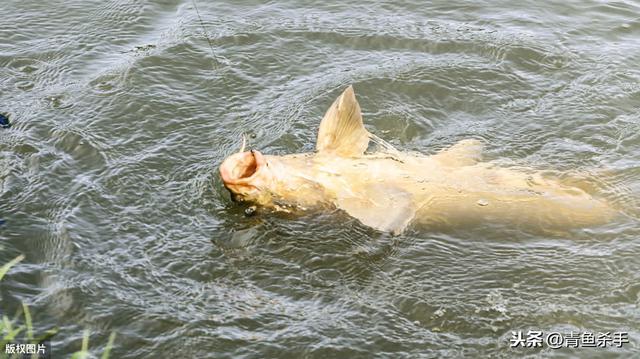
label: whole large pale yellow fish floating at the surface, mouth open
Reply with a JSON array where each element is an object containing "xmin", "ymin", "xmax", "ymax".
[{"xmin": 219, "ymin": 86, "xmax": 616, "ymax": 235}]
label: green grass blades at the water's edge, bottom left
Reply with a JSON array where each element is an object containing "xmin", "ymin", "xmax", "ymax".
[{"xmin": 0, "ymin": 255, "xmax": 116, "ymax": 359}]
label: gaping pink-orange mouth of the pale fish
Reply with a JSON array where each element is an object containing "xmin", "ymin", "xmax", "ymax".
[{"xmin": 220, "ymin": 150, "xmax": 266, "ymax": 188}]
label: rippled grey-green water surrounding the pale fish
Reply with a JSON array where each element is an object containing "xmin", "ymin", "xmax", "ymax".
[{"xmin": 0, "ymin": 0, "xmax": 640, "ymax": 358}]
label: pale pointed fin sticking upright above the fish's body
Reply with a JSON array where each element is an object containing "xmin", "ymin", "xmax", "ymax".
[{"xmin": 316, "ymin": 86, "xmax": 369, "ymax": 157}]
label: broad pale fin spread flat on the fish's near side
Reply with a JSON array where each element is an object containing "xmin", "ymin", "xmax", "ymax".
[{"xmin": 336, "ymin": 184, "xmax": 416, "ymax": 235}]
